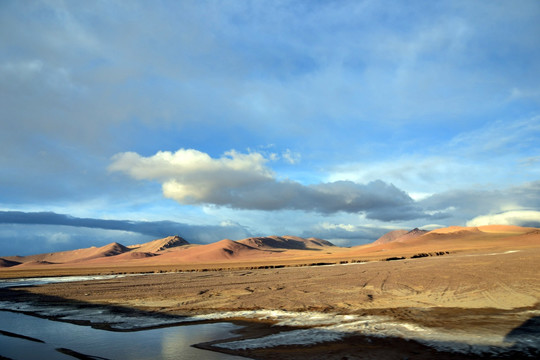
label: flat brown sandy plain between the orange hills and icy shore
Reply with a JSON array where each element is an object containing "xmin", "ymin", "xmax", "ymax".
[{"xmin": 7, "ymin": 248, "xmax": 540, "ymax": 313}]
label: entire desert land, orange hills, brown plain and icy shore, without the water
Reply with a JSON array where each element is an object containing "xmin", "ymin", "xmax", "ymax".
[{"xmin": 0, "ymin": 225, "xmax": 540, "ymax": 359}]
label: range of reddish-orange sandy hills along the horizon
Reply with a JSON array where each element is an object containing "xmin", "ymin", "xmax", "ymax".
[{"xmin": 0, "ymin": 225, "xmax": 540, "ymax": 271}]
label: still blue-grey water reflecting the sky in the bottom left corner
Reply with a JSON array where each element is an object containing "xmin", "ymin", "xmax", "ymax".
[{"xmin": 0, "ymin": 311, "xmax": 249, "ymax": 360}]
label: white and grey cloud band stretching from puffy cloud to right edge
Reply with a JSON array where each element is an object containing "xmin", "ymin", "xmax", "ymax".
[{"xmin": 109, "ymin": 149, "xmax": 540, "ymax": 228}]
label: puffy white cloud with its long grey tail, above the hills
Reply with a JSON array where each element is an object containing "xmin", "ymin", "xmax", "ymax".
[{"xmin": 109, "ymin": 149, "xmax": 426, "ymax": 221}]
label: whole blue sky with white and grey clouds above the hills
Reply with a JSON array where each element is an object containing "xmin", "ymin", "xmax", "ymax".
[{"xmin": 0, "ymin": 0, "xmax": 540, "ymax": 256}]
